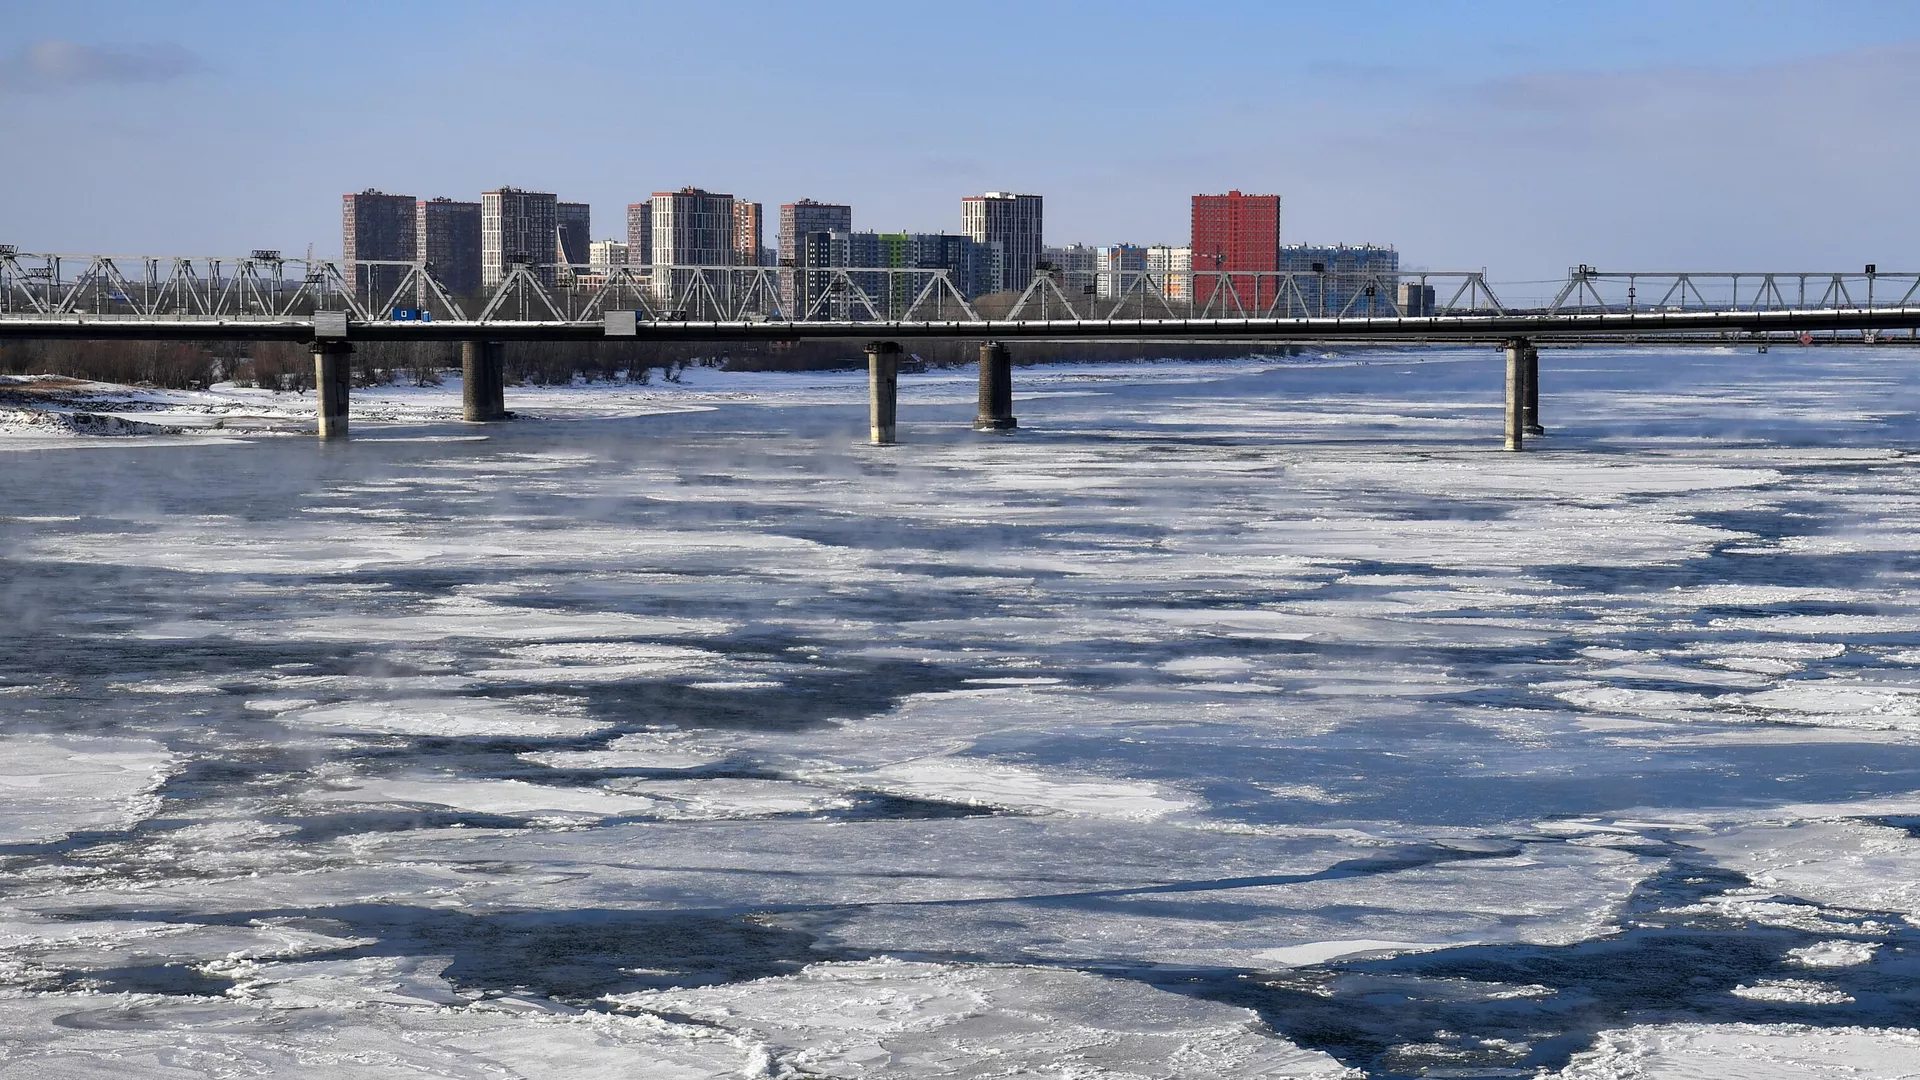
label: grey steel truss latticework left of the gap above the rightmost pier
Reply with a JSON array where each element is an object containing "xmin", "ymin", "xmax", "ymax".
[{"xmin": 0, "ymin": 246, "xmax": 1507, "ymax": 323}]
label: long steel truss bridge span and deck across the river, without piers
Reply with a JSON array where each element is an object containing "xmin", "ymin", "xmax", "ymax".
[{"xmin": 0, "ymin": 246, "xmax": 1920, "ymax": 342}]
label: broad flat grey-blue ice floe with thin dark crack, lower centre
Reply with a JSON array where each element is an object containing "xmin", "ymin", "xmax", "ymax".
[{"xmin": 266, "ymin": 817, "xmax": 1659, "ymax": 969}]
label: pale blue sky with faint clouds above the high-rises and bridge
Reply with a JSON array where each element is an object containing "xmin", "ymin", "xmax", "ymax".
[{"xmin": 0, "ymin": 0, "xmax": 1920, "ymax": 290}]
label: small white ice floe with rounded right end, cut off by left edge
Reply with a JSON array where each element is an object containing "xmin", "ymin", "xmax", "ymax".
[{"xmin": 0, "ymin": 736, "xmax": 175, "ymax": 844}]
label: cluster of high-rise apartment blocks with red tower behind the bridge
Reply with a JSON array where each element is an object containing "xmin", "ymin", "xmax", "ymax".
[{"xmin": 326, "ymin": 186, "xmax": 1367, "ymax": 311}]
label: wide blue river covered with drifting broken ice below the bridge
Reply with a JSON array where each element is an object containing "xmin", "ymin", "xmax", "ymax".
[{"xmin": 0, "ymin": 348, "xmax": 1920, "ymax": 1080}]
